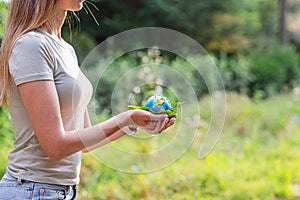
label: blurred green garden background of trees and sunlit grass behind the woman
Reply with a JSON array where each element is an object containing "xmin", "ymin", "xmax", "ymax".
[{"xmin": 0, "ymin": 0, "xmax": 300, "ymax": 200}]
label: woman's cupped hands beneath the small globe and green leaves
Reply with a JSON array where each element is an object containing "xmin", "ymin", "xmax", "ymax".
[{"xmin": 130, "ymin": 110, "xmax": 176, "ymax": 134}]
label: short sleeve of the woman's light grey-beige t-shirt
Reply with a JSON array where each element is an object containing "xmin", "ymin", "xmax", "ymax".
[{"xmin": 9, "ymin": 33, "xmax": 54, "ymax": 86}]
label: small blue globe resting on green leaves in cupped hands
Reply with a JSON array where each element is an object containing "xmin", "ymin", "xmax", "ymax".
[{"xmin": 145, "ymin": 94, "xmax": 171, "ymax": 113}]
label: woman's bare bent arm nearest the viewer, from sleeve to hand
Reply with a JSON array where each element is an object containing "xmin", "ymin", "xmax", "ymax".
[{"xmin": 18, "ymin": 81, "xmax": 170, "ymax": 161}]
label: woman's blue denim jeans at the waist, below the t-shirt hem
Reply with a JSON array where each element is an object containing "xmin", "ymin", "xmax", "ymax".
[{"xmin": 0, "ymin": 172, "xmax": 77, "ymax": 200}]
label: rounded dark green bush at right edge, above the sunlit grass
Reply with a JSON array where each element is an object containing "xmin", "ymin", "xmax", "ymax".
[{"xmin": 249, "ymin": 44, "xmax": 300, "ymax": 96}]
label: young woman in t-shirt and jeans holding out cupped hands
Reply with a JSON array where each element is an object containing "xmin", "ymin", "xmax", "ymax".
[{"xmin": 0, "ymin": 0, "xmax": 175, "ymax": 200}]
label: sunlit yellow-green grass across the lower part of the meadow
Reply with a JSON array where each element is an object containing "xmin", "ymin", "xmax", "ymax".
[{"xmin": 0, "ymin": 93, "xmax": 300, "ymax": 200}]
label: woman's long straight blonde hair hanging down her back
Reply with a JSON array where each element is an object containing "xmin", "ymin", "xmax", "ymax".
[{"xmin": 0, "ymin": 0, "xmax": 58, "ymax": 105}]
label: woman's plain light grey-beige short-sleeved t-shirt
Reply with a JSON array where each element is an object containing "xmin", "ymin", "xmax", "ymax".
[{"xmin": 8, "ymin": 29, "xmax": 92, "ymax": 185}]
